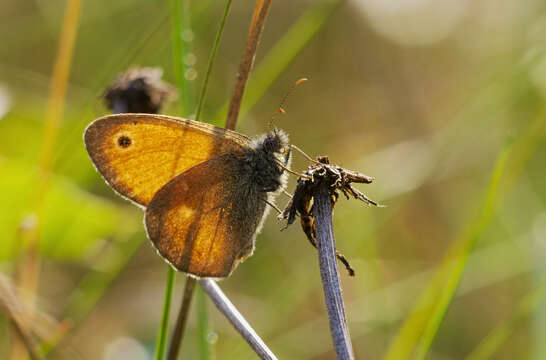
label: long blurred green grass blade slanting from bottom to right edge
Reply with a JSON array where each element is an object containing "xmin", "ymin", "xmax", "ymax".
[{"xmin": 384, "ymin": 108, "xmax": 546, "ymax": 360}]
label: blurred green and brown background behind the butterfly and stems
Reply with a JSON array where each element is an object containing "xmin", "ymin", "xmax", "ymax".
[{"xmin": 0, "ymin": 0, "xmax": 546, "ymax": 360}]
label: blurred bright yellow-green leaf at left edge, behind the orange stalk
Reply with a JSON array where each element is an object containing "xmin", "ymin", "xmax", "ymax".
[{"xmin": 0, "ymin": 155, "xmax": 127, "ymax": 261}]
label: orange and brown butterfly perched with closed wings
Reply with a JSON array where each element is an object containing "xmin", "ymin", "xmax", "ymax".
[{"xmin": 84, "ymin": 114, "xmax": 291, "ymax": 278}]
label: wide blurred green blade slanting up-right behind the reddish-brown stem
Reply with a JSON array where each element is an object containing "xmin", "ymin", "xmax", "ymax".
[{"xmin": 214, "ymin": 0, "xmax": 341, "ymax": 124}]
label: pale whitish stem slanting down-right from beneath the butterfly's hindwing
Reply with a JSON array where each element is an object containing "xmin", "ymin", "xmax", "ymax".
[{"xmin": 198, "ymin": 279, "xmax": 277, "ymax": 360}]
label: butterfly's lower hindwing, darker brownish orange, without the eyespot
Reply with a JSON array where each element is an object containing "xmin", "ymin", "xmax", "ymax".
[{"xmin": 145, "ymin": 153, "xmax": 266, "ymax": 277}]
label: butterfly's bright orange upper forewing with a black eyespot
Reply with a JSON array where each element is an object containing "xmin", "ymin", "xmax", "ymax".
[{"xmin": 84, "ymin": 114, "xmax": 250, "ymax": 206}]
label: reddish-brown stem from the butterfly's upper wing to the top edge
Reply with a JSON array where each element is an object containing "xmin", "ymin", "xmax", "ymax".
[{"xmin": 226, "ymin": 0, "xmax": 272, "ymax": 130}]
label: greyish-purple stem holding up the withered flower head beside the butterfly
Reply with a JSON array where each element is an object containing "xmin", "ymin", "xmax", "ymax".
[{"xmin": 313, "ymin": 183, "xmax": 354, "ymax": 360}]
